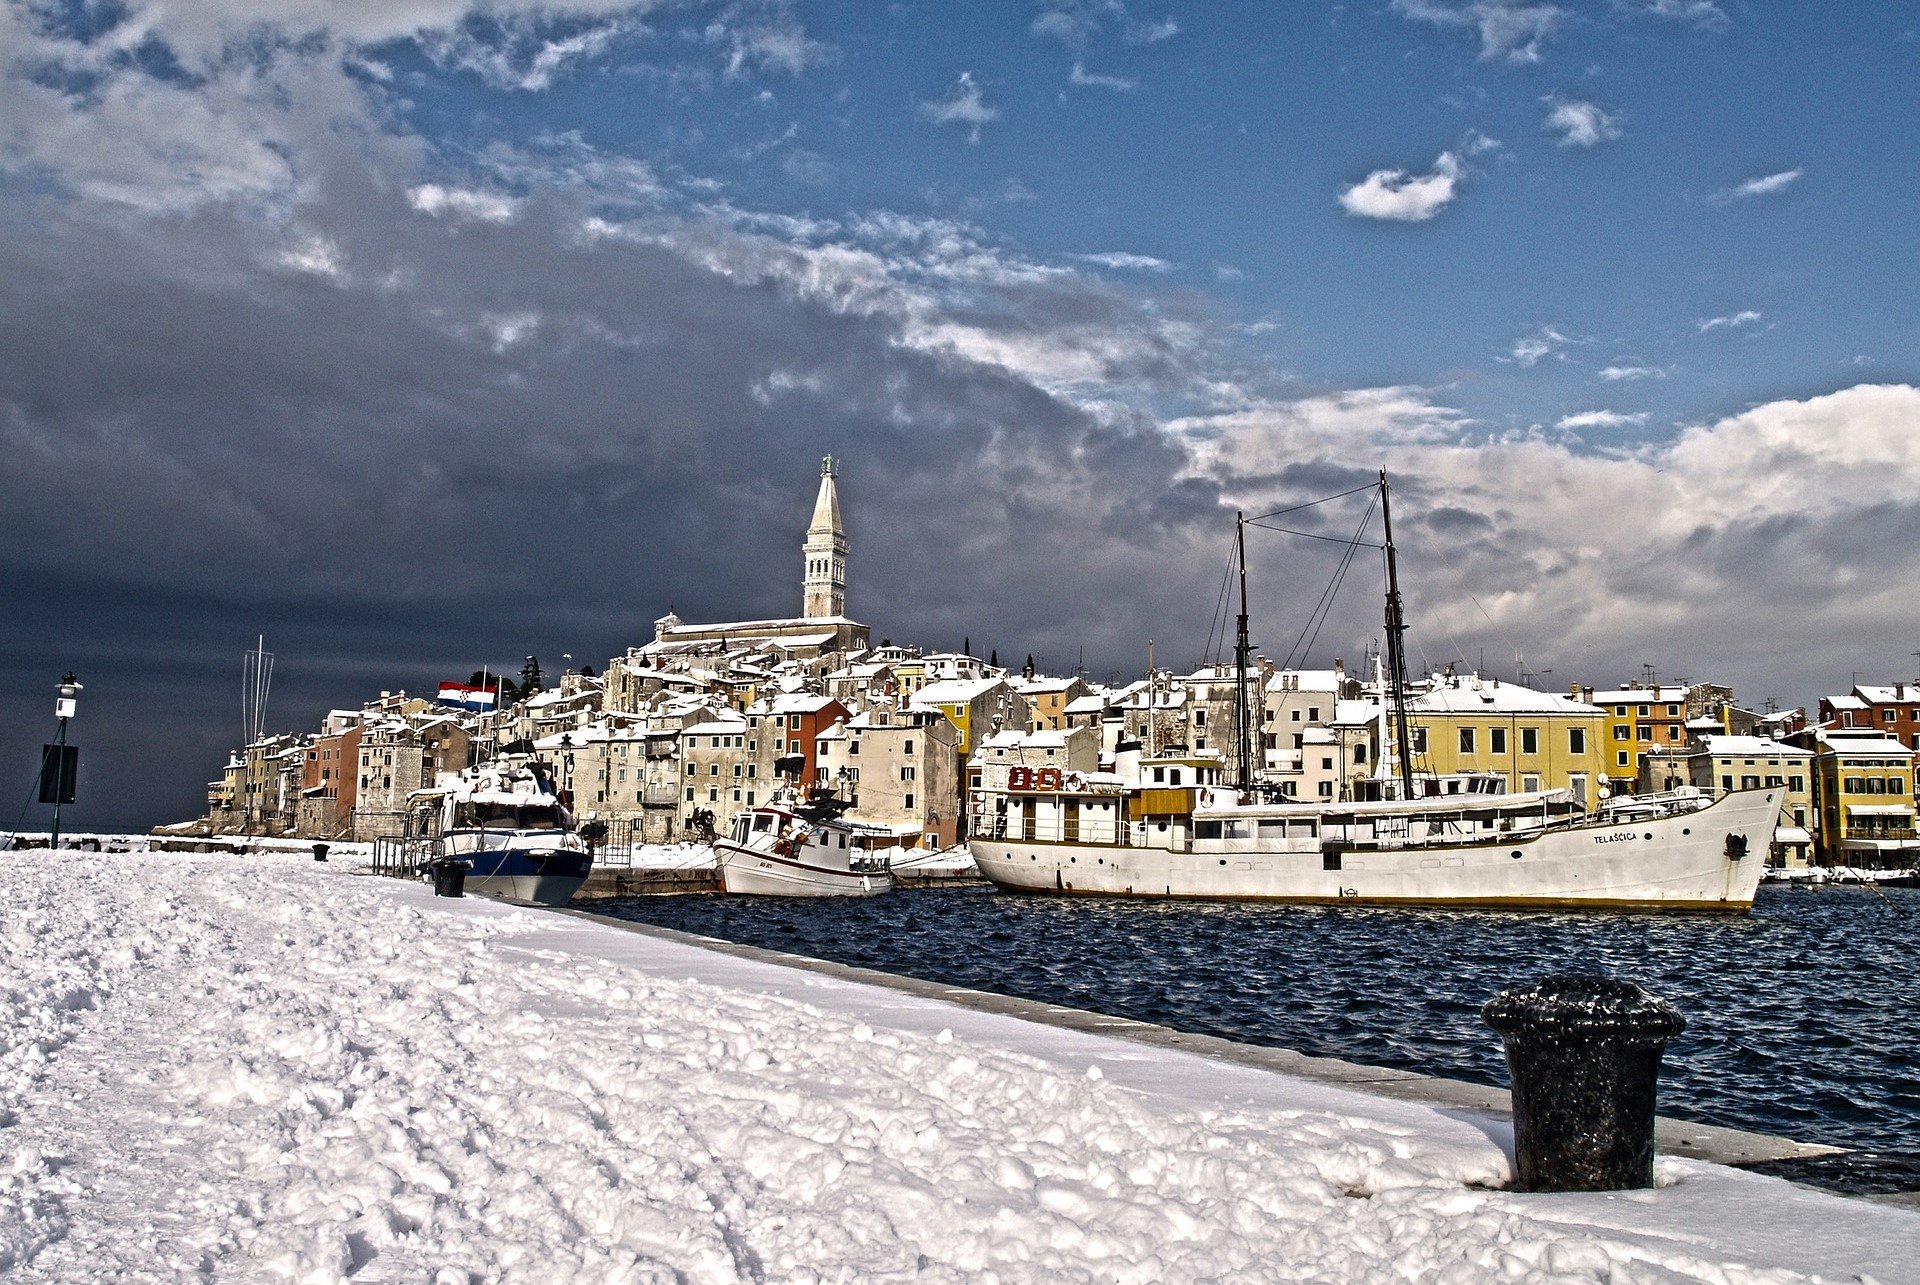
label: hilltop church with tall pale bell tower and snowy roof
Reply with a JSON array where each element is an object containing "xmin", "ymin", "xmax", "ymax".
[{"xmin": 639, "ymin": 455, "xmax": 868, "ymax": 661}]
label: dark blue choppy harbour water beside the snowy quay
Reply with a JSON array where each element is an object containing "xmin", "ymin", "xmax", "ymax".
[{"xmin": 595, "ymin": 887, "xmax": 1920, "ymax": 1151}]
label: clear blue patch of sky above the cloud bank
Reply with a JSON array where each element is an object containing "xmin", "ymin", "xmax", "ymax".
[{"xmin": 378, "ymin": 4, "xmax": 1920, "ymax": 436}]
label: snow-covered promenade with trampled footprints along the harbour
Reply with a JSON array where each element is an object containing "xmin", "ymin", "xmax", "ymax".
[{"xmin": 0, "ymin": 851, "xmax": 1920, "ymax": 1283}]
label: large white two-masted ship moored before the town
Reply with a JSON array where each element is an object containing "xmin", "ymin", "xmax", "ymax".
[{"xmin": 968, "ymin": 473, "xmax": 1784, "ymax": 912}]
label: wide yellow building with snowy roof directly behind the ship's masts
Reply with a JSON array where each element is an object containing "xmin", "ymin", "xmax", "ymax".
[{"xmin": 1407, "ymin": 674, "xmax": 1609, "ymax": 807}]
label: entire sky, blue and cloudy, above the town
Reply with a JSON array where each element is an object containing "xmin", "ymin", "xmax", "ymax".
[{"xmin": 0, "ymin": 0, "xmax": 1920, "ymax": 828}]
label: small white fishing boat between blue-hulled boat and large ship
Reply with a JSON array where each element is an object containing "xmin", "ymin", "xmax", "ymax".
[{"xmin": 714, "ymin": 791, "xmax": 893, "ymax": 897}]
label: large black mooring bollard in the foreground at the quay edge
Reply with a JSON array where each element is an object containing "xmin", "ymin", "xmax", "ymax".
[{"xmin": 1480, "ymin": 974, "xmax": 1686, "ymax": 1191}]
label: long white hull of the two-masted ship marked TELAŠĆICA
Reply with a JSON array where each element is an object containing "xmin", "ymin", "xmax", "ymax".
[{"xmin": 970, "ymin": 791, "xmax": 1780, "ymax": 914}]
